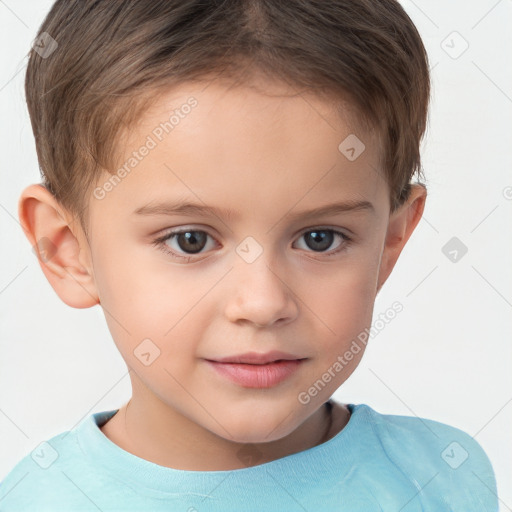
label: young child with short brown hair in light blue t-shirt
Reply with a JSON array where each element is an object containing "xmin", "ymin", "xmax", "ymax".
[{"xmin": 0, "ymin": 0, "xmax": 498, "ymax": 512}]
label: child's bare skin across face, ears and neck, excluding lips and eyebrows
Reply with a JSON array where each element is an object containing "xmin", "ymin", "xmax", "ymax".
[{"xmin": 19, "ymin": 74, "xmax": 426, "ymax": 471}]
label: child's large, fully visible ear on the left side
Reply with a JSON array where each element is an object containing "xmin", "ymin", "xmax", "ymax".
[{"xmin": 18, "ymin": 184, "xmax": 99, "ymax": 308}]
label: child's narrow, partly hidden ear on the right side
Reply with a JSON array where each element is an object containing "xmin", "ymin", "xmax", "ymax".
[{"xmin": 377, "ymin": 183, "xmax": 427, "ymax": 293}]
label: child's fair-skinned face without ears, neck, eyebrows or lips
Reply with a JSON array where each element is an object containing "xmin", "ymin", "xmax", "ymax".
[{"xmin": 58, "ymin": 76, "xmax": 420, "ymax": 442}]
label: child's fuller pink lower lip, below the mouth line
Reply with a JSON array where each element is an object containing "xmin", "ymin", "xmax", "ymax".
[{"xmin": 207, "ymin": 359, "xmax": 304, "ymax": 388}]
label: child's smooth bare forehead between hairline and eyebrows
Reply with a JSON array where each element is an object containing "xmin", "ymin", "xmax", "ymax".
[{"xmin": 93, "ymin": 80, "xmax": 387, "ymax": 220}]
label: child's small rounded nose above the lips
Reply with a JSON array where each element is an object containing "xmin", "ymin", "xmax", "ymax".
[{"xmin": 225, "ymin": 251, "xmax": 299, "ymax": 327}]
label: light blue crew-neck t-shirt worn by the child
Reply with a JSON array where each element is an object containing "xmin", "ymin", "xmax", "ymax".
[{"xmin": 0, "ymin": 404, "xmax": 498, "ymax": 512}]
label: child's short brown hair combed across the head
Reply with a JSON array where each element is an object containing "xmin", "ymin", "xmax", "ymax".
[{"xmin": 25, "ymin": 0, "xmax": 430, "ymax": 236}]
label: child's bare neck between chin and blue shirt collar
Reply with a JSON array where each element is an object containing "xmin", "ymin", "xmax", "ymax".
[{"xmin": 101, "ymin": 392, "xmax": 346, "ymax": 471}]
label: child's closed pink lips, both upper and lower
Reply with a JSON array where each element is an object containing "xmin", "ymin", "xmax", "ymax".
[{"xmin": 206, "ymin": 352, "xmax": 306, "ymax": 389}]
